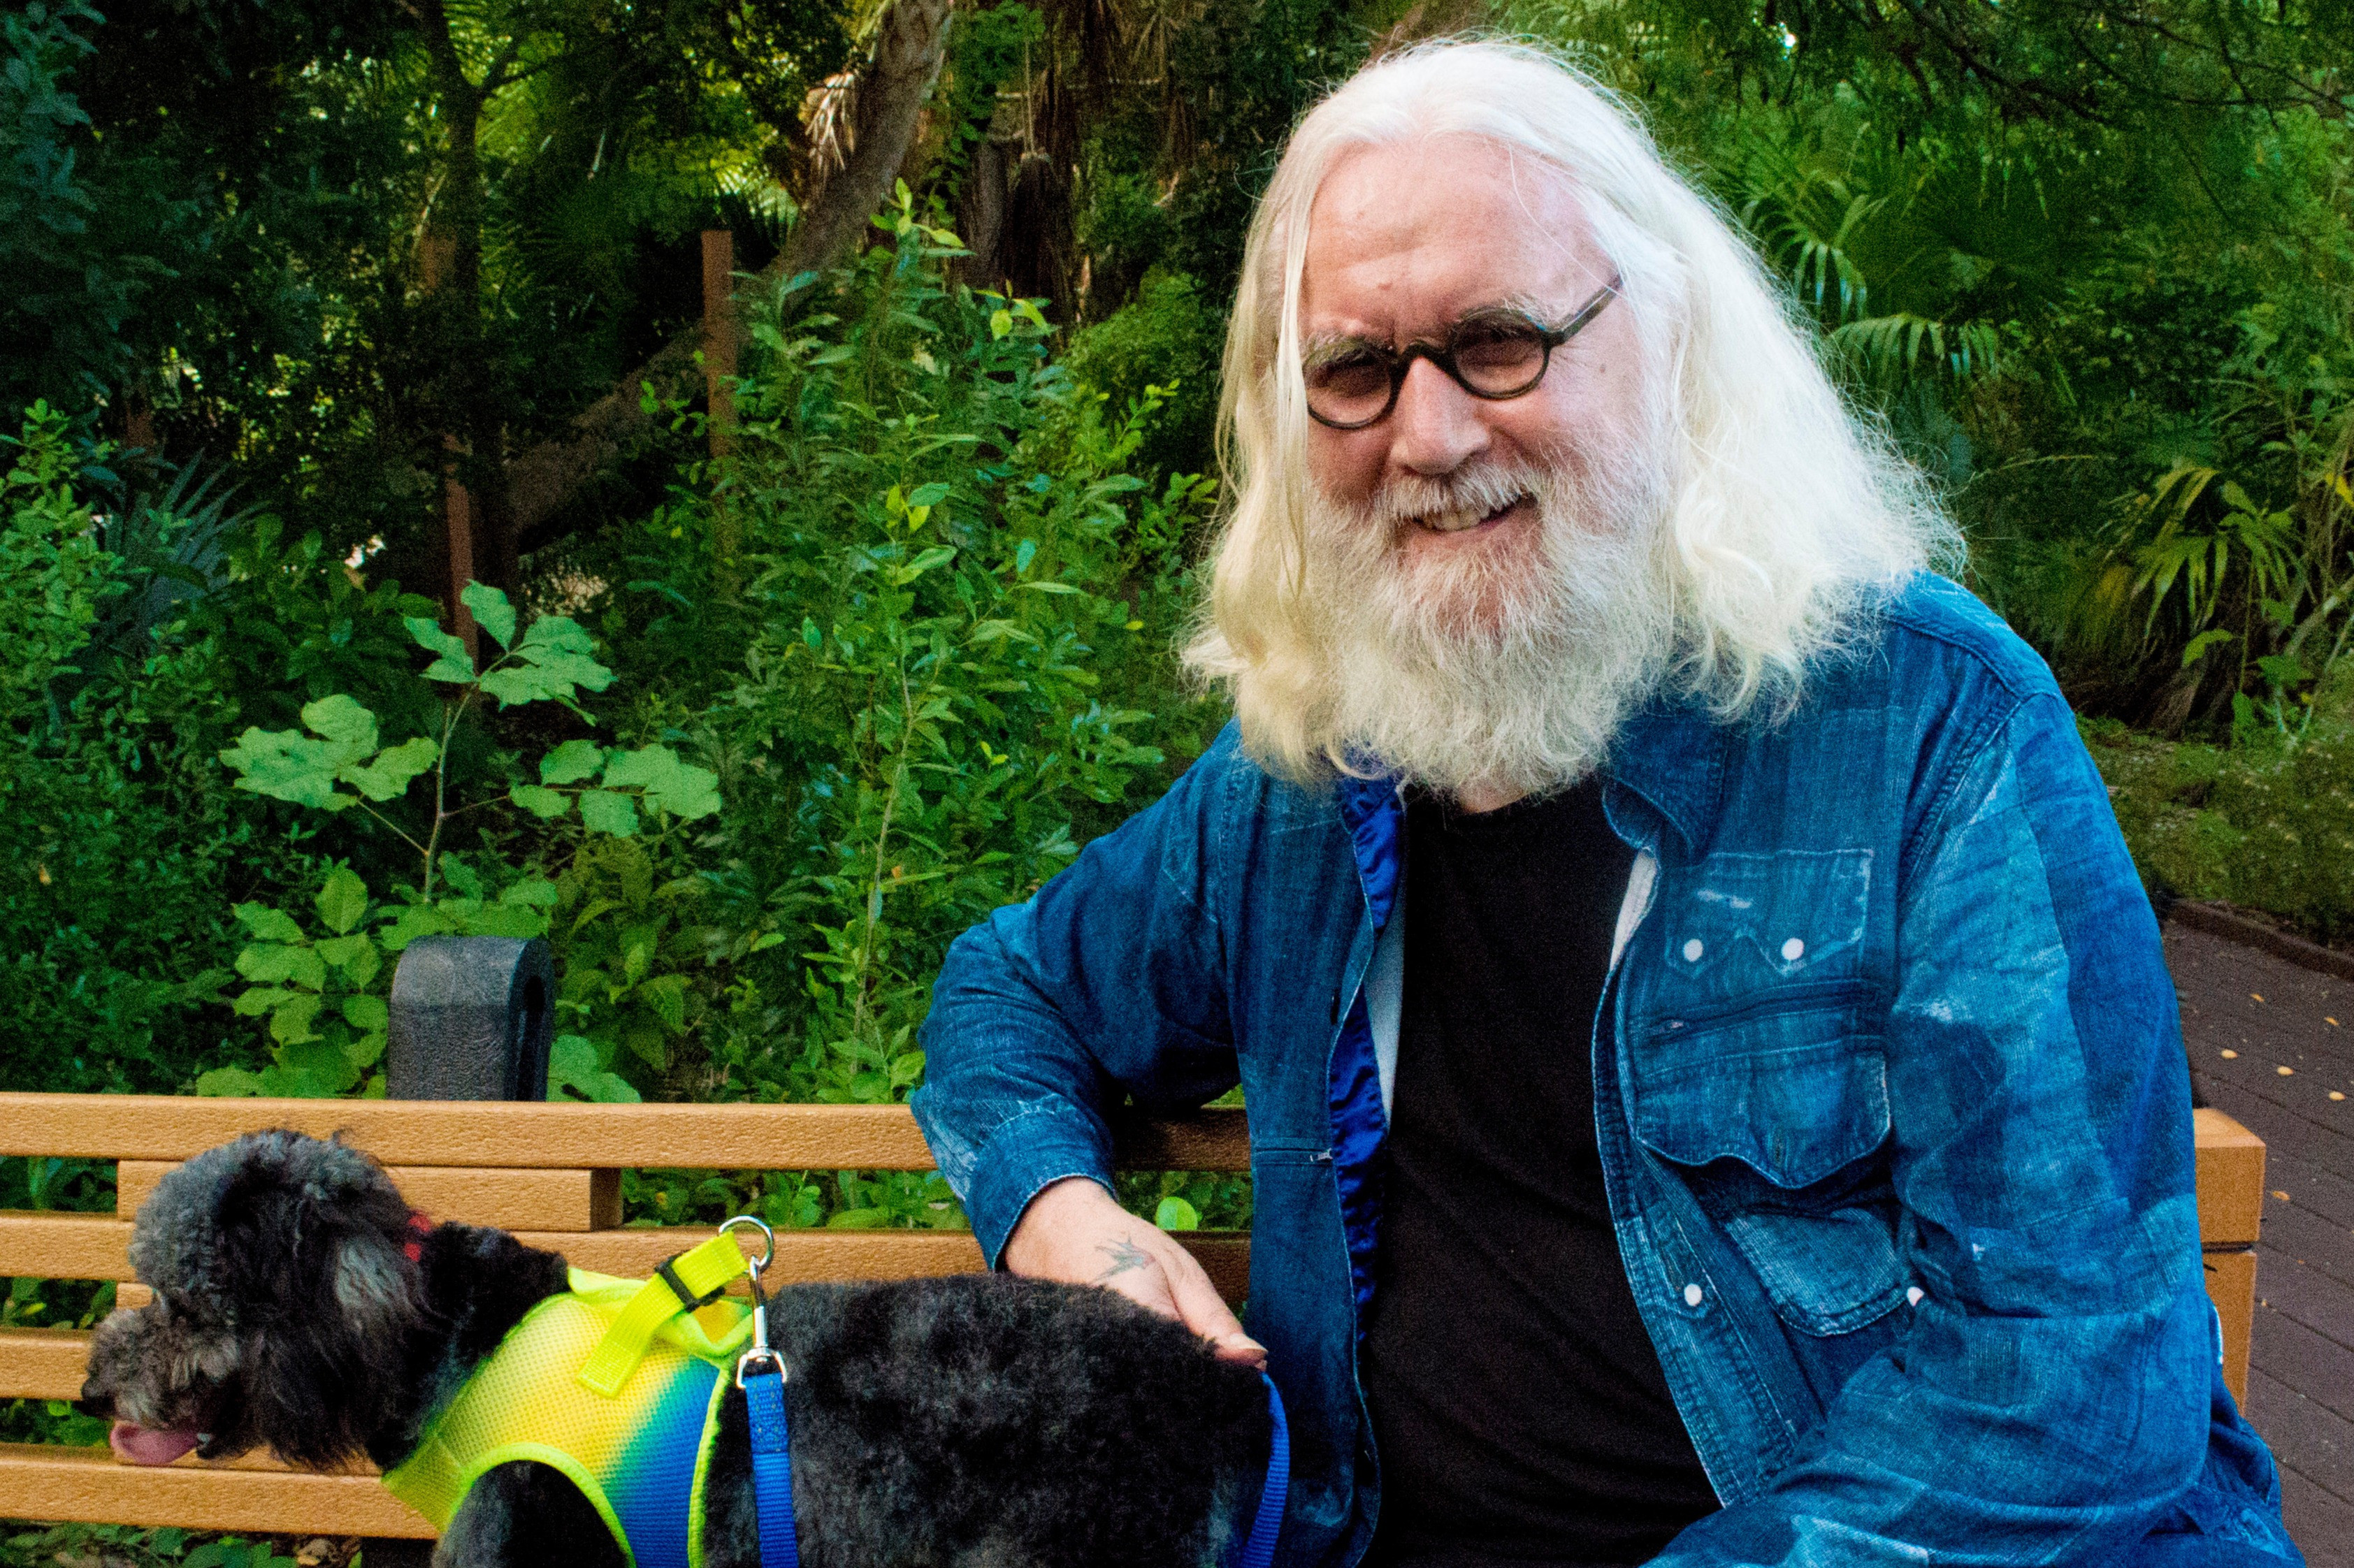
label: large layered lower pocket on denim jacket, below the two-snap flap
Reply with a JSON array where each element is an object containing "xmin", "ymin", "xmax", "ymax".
[{"xmin": 1633, "ymin": 982, "xmax": 1905, "ymax": 1335}]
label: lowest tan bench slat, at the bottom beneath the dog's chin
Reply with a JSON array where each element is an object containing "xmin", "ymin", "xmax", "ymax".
[{"xmin": 0, "ymin": 1443, "xmax": 433, "ymax": 1540}]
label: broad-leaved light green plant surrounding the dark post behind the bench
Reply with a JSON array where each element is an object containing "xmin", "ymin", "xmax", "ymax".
[{"xmin": 208, "ymin": 584, "xmax": 721, "ymax": 1099}]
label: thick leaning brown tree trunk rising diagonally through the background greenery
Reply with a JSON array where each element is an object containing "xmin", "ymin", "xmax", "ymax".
[{"xmin": 504, "ymin": 0, "xmax": 948, "ymax": 549}]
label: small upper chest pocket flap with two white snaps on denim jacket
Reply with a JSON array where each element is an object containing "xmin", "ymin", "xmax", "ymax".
[{"xmin": 1662, "ymin": 850, "xmax": 1872, "ymax": 999}]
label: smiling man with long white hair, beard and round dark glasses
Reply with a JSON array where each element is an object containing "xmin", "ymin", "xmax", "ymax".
[{"xmin": 916, "ymin": 45, "xmax": 2297, "ymax": 1568}]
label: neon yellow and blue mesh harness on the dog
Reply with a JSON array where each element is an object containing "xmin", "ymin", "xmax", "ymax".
[{"xmin": 384, "ymin": 1234, "xmax": 751, "ymax": 1568}]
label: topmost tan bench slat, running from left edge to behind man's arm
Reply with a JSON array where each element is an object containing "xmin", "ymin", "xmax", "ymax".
[{"xmin": 0, "ymin": 1092, "xmax": 1250, "ymax": 1170}]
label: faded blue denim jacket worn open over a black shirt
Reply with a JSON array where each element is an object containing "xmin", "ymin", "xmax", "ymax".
[{"xmin": 916, "ymin": 576, "xmax": 2300, "ymax": 1568}]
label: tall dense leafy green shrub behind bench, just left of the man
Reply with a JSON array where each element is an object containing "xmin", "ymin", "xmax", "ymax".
[{"xmin": 654, "ymin": 195, "xmax": 1205, "ymax": 1102}]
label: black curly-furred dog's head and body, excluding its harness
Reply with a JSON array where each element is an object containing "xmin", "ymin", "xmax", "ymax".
[{"xmin": 82, "ymin": 1133, "xmax": 1271, "ymax": 1568}]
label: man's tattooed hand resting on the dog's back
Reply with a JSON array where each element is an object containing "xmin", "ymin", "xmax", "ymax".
[{"xmin": 1003, "ymin": 1177, "xmax": 1266, "ymax": 1365}]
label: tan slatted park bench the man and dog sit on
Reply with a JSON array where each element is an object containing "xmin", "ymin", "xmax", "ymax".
[{"xmin": 0, "ymin": 944, "xmax": 2265, "ymax": 1534}]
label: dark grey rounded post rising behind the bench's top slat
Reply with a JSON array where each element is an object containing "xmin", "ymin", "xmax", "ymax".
[{"xmin": 360, "ymin": 937, "xmax": 556, "ymax": 1568}]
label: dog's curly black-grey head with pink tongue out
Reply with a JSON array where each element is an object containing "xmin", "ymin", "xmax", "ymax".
[{"xmin": 82, "ymin": 1133, "xmax": 426, "ymax": 1465}]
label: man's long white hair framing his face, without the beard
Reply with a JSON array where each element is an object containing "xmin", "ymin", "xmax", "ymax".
[{"xmin": 1186, "ymin": 40, "xmax": 1958, "ymax": 786}]
